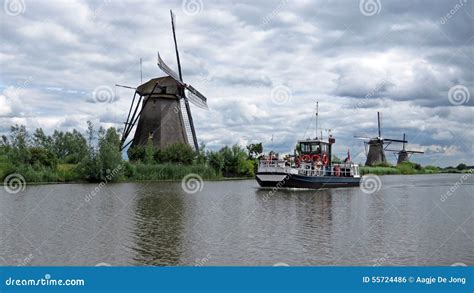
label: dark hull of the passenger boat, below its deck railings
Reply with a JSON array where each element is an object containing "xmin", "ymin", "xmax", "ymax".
[{"xmin": 255, "ymin": 172, "xmax": 361, "ymax": 189}]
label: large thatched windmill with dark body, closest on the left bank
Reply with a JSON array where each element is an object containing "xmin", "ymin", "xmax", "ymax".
[{"xmin": 120, "ymin": 10, "xmax": 207, "ymax": 151}]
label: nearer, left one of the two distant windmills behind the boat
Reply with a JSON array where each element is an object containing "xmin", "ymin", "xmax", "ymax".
[{"xmin": 355, "ymin": 112, "xmax": 407, "ymax": 166}]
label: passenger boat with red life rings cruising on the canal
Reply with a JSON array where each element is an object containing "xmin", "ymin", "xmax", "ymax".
[{"xmin": 255, "ymin": 106, "xmax": 361, "ymax": 189}]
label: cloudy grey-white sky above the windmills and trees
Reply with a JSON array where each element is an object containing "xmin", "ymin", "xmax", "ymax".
[{"xmin": 0, "ymin": 0, "xmax": 474, "ymax": 166}]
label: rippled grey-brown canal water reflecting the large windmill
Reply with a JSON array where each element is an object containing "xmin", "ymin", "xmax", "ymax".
[{"xmin": 0, "ymin": 174, "xmax": 474, "ymax": 266}]
